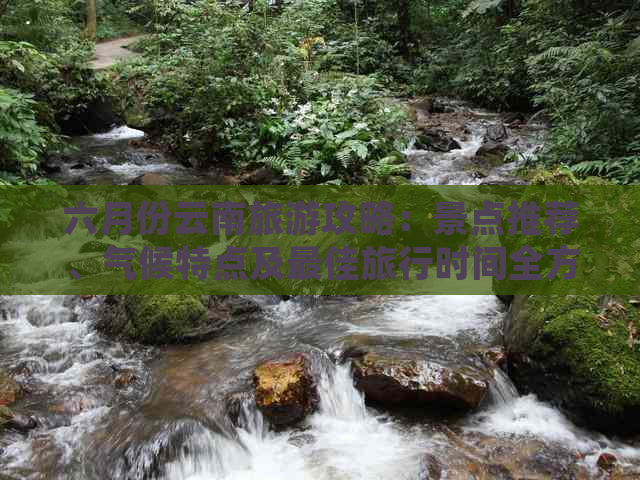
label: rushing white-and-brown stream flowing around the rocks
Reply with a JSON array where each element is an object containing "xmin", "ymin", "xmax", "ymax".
[{"xmin": 0, "ymin": 99, "xmax": 640, "ymax": 480}]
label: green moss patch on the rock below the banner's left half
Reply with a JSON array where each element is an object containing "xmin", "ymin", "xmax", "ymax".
[{"xmin": 125, "ymin": 295, "xmax": 207, "ymax": 344}]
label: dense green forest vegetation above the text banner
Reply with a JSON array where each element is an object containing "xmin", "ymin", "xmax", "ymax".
[{"xmin": 0, "ymin": 0, "xmax": 640, "ymax": 183}]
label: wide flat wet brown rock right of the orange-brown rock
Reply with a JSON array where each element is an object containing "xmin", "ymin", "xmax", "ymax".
[{"xmin": 352, "ymin": 353, "xmax": 488, "ymax": 410}]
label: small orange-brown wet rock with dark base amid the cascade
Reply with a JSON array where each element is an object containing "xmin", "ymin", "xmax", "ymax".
[{"xmin": 253, "ymin": 354, "xmax": 318, "ymax": 430}]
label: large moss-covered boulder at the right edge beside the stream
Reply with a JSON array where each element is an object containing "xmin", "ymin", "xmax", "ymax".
[{"xmin": 505, "ymin": 296, "xmax": 640, "ymax": 433}]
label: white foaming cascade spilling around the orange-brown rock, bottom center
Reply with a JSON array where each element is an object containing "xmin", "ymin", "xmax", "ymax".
[{"xmin": 156, "ymin": 365, "xmax": 419, "ymax": 480}]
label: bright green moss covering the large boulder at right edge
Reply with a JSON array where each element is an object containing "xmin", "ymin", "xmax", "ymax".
[{"xmin": 528, "ymin": 296, "xmax": 640, "ymax": 415}]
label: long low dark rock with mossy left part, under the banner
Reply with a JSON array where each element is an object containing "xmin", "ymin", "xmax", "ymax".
[{"xmin": 96, "ymin": 295, "xmax": 262, "ymax": 344}]
